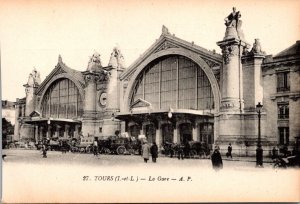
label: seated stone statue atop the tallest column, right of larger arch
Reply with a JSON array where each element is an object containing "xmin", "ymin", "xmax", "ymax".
[{"xmin": 224, "ymin": 7, "xmax": 244, "ymax": 40}]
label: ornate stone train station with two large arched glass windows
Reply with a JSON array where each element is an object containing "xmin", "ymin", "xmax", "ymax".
[{"xmin": 15, "ymin": 7, "xmax": 300, "ymax": 154}]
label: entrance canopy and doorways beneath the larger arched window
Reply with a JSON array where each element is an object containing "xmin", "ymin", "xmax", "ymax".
[{"xmin": 115, "ymin": 108, "xmax": 214, "ymax": 147}]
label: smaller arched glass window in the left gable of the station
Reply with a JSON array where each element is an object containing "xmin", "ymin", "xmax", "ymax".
[{"xmin": 41, "ymin": 79, "xmax": 83, "ymax": 119}]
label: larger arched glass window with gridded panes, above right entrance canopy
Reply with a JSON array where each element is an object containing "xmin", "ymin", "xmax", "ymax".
[{"xmin": 131, "ymin": 55, "xmax": 214, "ymax": 110}]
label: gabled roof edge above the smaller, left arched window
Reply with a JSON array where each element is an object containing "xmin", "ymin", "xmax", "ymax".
[{"xmin": 36, "ymin": 56, "xmax": 85, "ymax": 94}]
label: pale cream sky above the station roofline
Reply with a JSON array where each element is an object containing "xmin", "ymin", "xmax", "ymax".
[{"xmin": 0, "ymin": 0, "xmax": 300, "ymax": 101}]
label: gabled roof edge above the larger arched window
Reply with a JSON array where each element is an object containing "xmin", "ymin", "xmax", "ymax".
[{"xmin": 120, "ymin": 27, "xmax": 222, "ymax": 79}]
